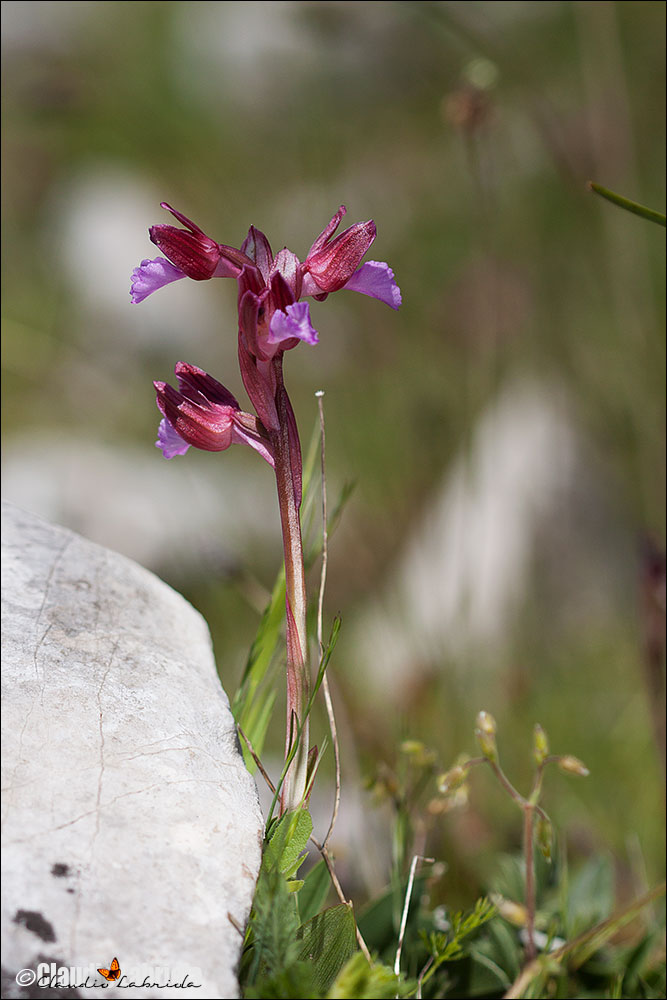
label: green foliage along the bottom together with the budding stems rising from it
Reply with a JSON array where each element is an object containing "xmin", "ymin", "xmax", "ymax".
[{"xmin": 243, "ymin": 660, "xmax": 665, "ymax": 1000}]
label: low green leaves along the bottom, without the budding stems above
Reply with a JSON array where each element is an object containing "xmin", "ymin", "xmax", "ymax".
[{"xmin": 240, "ymin": 745, "xmax": 665, "ymax": 1000}]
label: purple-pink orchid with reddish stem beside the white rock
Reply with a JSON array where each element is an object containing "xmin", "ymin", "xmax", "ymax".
[{"xmin": 130, "ymin": 202, "xmax": 401, "ymax": 812}]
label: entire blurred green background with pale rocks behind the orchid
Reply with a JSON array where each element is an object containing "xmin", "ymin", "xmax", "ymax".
[{"xmin": 2, "ymin": 0, "xmax": 665, "ymax": 903}]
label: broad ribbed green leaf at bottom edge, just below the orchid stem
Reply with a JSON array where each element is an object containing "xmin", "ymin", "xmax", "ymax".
[{"xmin": 297, "ymin": 903, "xmax": 357, "ymax": 994}]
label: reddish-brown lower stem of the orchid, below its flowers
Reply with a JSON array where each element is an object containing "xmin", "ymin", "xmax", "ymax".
[{"xmin": 272, "ymin": 359, "xmax": 310, "ymax": 813}]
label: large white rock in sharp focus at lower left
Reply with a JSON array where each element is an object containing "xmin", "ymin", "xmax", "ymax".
[{"xmin": 2, "ymin": 505, "xmax": 262, "ymax": 998}]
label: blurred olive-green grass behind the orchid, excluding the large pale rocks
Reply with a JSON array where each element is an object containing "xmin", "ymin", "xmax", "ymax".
[{"xmin": 2, "ymin": 2, "xmax": 665, "ymax": 904}]
